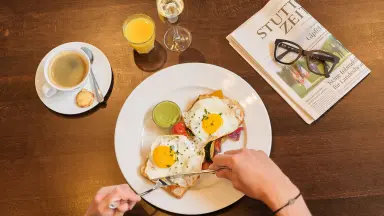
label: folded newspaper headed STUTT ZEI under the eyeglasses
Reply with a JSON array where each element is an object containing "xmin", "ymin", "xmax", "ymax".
[{"xmin": 227, "ymin": 0, "xmax": 370, "ymax": 124}]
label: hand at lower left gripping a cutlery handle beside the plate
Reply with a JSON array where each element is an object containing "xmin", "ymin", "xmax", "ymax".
[{"xmin": 85, "ymin": 184, "xmax": 141, "ymax": 216}]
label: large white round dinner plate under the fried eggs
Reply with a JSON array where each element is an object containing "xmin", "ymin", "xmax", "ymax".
[{"xmin": 115, "ymin": 63, "xmax": 272, "ymax": 215}]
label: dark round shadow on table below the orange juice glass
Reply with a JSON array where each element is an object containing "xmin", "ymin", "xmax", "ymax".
[{"xmin": 133, "ymin": 41, "xmax": 167, "ymax": 72}]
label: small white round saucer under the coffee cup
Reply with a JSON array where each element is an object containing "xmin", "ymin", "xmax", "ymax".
[{"xmin": 35, "ymin": 42, "xmax": 112, "ymax": 115}]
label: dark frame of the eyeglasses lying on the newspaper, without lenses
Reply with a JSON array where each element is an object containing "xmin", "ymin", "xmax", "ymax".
[{"xmin": 274, "ymin": 39, "xmax": 340, "ymax": 78}]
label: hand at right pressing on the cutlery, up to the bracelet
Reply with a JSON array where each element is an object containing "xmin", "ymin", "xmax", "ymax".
[{"xmin": 210, "ymin": 148, "xmax": 299, "ymax": 209}]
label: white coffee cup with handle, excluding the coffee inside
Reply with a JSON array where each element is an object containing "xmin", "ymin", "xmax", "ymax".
[{"xmin": 42, "ymin": 48, "xmax": 91, "ymax": 97}]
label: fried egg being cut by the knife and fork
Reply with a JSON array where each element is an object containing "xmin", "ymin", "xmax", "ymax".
[{"xmin": 145, "ymin": 135, "xmax": 204, "ymax": 187}]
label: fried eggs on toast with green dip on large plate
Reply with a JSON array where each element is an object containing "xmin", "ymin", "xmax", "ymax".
[{"xmin": 141, "ymin": 90, "xmax": 244, "ymax": 198}]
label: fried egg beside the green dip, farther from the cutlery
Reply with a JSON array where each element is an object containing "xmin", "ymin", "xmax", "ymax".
[{"xmin": 183, "ymin": 96, "xmax": 244, "ymax": 144}]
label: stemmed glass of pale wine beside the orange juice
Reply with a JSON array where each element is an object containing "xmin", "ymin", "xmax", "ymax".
[{"xmin": 157, "ymin": 0, "xmax": 192, "ymax": 52}]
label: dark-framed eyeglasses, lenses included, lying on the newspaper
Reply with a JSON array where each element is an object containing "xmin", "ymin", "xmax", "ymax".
[{"xmin": 275, "ymin": 39, "xmax": 340, "ymax": 78}]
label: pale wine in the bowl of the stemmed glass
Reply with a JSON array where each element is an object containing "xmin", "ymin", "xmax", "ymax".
[{"xmin": 157, "ymin": 0, "xmax": 184, "ymax": 23}]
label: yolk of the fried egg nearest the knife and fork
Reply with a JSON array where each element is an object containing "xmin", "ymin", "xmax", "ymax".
[{"xmin": 152, "ymin": 146, "xmax": 176, "ymax": 168}]
